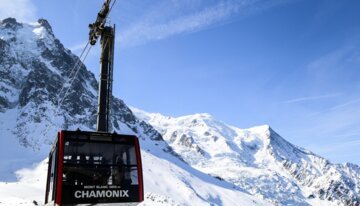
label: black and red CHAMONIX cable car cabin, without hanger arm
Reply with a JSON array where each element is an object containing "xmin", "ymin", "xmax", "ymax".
[{"xmin": 45, "ymin": 131, "xmax": 144, "ymax": 205}]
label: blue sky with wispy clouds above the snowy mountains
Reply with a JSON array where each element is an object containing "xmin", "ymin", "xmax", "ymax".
[{"xmin": 0, "ymin": 0, "xmax": 360, "ymax": 164}]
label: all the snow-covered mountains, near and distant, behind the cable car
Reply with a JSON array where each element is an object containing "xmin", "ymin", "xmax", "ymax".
[{"xmin": 0, "ymin": 18, "xmax": 360, "ymax": 206}]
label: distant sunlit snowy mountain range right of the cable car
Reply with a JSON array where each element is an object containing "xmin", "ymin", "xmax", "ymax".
[{"xmin": 132, "ymin": 108, "xmax": 360, "ymax": 205}]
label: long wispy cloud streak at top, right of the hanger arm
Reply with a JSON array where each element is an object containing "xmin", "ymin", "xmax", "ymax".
[{"xmin": 118, "ymin": 0, "xmax": 287, "ymax": 47}]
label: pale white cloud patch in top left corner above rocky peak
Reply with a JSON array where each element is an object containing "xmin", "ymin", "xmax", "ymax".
[{"xmin": 0, "ymin": 0, "xmax": 36, "ymax": 22}]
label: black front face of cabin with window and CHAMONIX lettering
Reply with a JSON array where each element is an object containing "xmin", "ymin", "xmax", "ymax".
[{"xmin": 62, "ymin": 140, "xmax": 139, "ymax": 204}]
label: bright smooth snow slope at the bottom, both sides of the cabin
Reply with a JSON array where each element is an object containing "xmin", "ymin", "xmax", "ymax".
[{"xmin": 0, "ymin": 136, "xmax": 268, "ymax": 206}]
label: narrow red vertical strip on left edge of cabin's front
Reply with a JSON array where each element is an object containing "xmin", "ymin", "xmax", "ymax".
[{"xmin": 55, "ymin": 131, "xmax": 65, "ymax": 205}]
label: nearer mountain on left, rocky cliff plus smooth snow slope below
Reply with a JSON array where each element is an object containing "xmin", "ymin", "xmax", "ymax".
[{"xmin": 0, "ymin": 18, "xmax": 265, "ymax": 205}]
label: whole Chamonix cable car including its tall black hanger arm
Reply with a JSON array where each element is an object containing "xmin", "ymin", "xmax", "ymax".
[{"xmin": 45, "ymin": 0, "xmax": 144, "ymax": 205}]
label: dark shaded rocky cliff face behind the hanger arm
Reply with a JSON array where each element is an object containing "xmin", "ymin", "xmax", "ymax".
[{"xmin": 0, "ymin": 18, "xmax": 162, "ymax": 149}]
